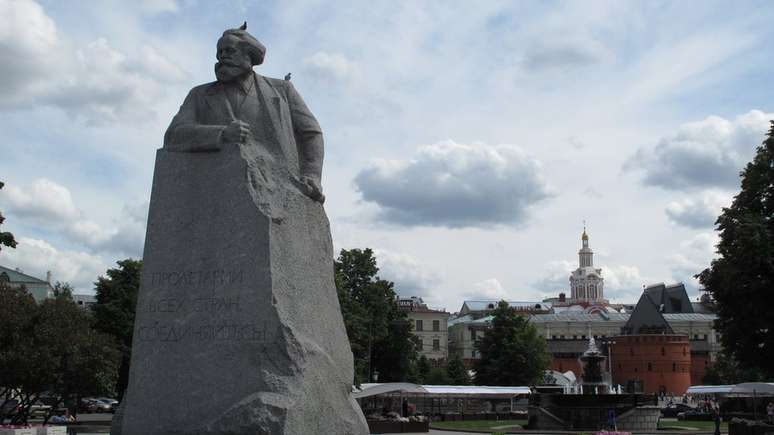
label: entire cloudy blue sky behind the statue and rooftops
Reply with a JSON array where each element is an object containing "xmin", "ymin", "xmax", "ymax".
[{"xmin": 0, "ymin": 0, "xmax": 774, "ymax": 311}]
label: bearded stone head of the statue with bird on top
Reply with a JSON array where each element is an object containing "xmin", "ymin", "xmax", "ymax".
[{"xmin": 215, "ymin": 22, "xmax": 266, "ymax": 82}]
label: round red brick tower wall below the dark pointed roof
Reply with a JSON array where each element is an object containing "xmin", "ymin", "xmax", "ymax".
[{"xmin": 612, "ymin": 335, "xmax": 691, "ymax": 394}]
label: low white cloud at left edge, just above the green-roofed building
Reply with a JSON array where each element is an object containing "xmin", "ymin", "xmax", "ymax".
[{"xmin": 0, "ymin": 237, "xmax": 107, "ymax": 291}]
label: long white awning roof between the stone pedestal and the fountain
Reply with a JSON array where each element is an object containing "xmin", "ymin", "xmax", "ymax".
[{"xmin": 352, "ymin": 382, "xmax": 530, "ymax": 399}]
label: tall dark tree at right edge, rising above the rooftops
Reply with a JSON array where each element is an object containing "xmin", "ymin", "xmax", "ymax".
[{"xmin": 697, "ymin": 122, "xmax": 774, "ymax": 378}]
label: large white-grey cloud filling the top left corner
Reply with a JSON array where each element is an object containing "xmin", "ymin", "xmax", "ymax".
[{"xmin": 0, "ymin": 0, "xmax": 185, "ymax": 125}]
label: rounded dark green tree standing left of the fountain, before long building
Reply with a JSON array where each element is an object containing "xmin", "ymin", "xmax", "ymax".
[{"xmin": 475, "ymin": 301, "xmax": 551, "ymax": 386}]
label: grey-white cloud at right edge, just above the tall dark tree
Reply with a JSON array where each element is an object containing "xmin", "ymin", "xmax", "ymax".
[{"xmin": 624, "ymin": 110, "xmax": 774, "ymax": 190}]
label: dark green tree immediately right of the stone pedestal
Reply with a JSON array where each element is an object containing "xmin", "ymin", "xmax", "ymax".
[{"xmin": 334, "ymin": 249, "xmax": 416, "ymax": 385}]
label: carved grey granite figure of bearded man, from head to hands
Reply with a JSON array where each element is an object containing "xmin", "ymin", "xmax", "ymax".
[{"xmin": 164, "ymin": 23, "xmax": 325, "ymax": 202}]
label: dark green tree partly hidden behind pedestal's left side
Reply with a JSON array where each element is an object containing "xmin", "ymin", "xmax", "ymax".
[{"xmin": 92, "ymin": 259, "xmax": 142, "ymax": 400}]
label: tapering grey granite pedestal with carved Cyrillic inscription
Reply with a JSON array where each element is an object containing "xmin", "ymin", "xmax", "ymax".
[{"xmin": 113, "ymin": 145, "xmax": 368, "ymax": 435}]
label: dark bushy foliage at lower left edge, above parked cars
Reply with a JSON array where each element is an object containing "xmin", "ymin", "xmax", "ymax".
[{"xmin": 0, "ymin": 283, "xmax": 119, "ymax": 423}]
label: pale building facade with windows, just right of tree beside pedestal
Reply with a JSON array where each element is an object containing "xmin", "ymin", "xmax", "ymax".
[{"xmin": 398, "ymin": 296, "xmax": 449, "ymax": 366}]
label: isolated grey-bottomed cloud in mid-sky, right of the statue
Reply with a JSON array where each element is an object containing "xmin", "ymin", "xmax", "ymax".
[{"xmin": 355, "ymin": 140, "xmax": 552, "ymax": 228}]
